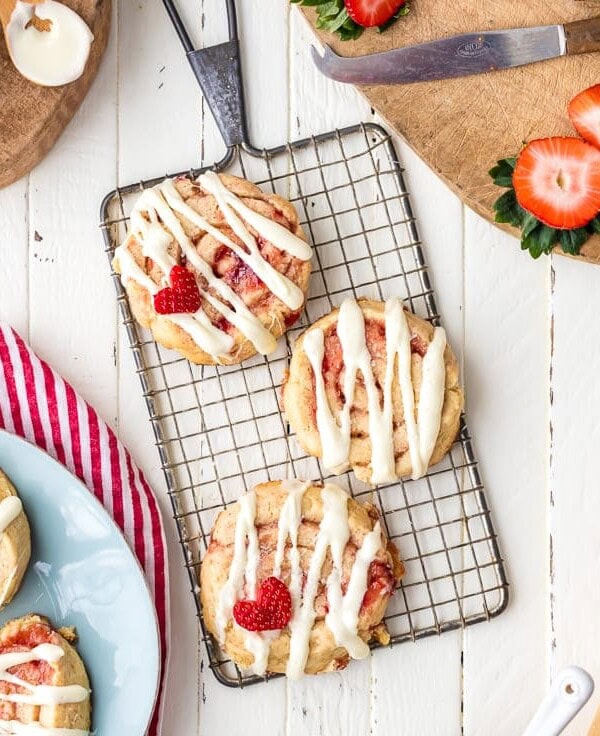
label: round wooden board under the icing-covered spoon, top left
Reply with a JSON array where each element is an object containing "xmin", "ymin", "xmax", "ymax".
[{"xmin": 0, "ymin": 0, "xmax": 111, "ymax": 187}]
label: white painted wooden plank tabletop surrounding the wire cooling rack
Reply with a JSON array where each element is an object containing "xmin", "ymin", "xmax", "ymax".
[{"xmin": 0, "ymin": 0, "xmax": 600, "ymax": 736}]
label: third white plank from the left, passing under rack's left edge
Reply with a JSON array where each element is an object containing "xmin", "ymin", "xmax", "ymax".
[{"xmin": 115, "ymin": 0, "xmax": 201, "ymax": 734}]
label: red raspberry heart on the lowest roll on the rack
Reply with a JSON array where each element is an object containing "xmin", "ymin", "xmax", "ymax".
[{"xmin": 233, "ymin": 576, "xmax": 292, "ymax": 631}]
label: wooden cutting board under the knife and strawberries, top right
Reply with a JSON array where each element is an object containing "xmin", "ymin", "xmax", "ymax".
[{"xmin": 305, "ymin": 0, "xmax": 600, "ymax": 263}]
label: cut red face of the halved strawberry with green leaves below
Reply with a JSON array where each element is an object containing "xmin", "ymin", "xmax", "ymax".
[{"xmin": 513, "ymin": 138, "xmax": 600, "ymax": 230}]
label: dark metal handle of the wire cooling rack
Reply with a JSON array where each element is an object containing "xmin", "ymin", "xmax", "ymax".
[{"xmin": 163, "ymin": 0, "xmax": 248, "ymax": 148}]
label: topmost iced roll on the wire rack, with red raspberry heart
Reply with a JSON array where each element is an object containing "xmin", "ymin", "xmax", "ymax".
[{"xmin": 113, "ymin": 171, "xmax": 312, "ymax": 365}]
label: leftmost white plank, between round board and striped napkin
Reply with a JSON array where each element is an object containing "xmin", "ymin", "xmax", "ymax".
[{"xmin": 0, "ymin": 176, "xmax": 29, "ymax": 339}]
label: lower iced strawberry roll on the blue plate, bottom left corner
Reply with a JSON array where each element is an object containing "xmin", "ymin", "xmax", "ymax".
[{"xmin": 0, "ymin": 614, "xmax": 91, "ymax": 736}]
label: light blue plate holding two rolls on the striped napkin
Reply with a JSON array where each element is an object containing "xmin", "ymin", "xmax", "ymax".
[{"xmin": 0, "ymin": 431, "xmax": 160, "ymax": 736}]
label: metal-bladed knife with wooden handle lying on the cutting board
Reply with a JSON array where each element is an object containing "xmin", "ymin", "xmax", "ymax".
[{"xmin": 311, "ymin": 16, "xmax": 600, "ymax": 84}]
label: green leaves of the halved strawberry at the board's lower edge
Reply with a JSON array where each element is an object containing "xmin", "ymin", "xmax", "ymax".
[{"xmin": 489, "ymin": 158, "xmax": 600, "ymax": 258}]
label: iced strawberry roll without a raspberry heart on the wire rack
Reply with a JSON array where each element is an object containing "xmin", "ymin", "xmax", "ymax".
[{"xmin": 282, "ymin": 299, "xmax": 463, "ymax": 484}]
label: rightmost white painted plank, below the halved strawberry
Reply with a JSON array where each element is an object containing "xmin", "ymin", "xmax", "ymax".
[{"xmin": 550, "ymin": 257, "xmax": 600, "ymax": 736}]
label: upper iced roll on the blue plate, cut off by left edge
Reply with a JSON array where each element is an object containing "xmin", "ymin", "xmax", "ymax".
[{"xmin": 0, "ymin": 470, "xmax": 31, "ymax": 608}]
